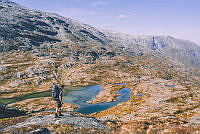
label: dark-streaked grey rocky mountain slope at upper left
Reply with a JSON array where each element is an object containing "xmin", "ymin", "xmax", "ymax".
[{"xmin": 0, "ymin": 1, "xmax": 110, "ymax": 51}]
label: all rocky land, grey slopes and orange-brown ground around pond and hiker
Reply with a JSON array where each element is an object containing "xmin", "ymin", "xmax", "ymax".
[{"xmin": 0, "ymin": 0, "xmax": 200, "ymax": 134}]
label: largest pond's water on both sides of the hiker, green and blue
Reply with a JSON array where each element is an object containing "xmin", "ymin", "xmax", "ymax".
[{"xmin": 0, "ymin": 83, "xmax": 130, "ymax": 114}]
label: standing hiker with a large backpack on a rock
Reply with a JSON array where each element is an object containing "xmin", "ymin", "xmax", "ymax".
[{"xmin": 52, "ymin": 83, "xmax": 64, "ymax": 118}]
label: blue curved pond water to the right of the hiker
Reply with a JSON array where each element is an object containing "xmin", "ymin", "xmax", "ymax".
[{"xmin": 63, "ymin": 85, "xmax": 130, "ymax": 114}]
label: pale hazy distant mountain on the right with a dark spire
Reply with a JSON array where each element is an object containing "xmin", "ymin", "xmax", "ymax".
[{"xmin": 103, "ymin": 30, "xmax": 200, "ymax": 68}]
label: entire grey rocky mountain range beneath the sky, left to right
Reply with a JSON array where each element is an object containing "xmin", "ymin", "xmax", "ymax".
[{"xmin": 0, "ymin": 0, "xmax": 200, "ymax": 67}]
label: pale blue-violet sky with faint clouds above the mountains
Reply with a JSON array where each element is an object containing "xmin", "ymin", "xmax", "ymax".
[{"xmin": 12, "ymin": 0, "xmax": 200, "ymax": 45}]
